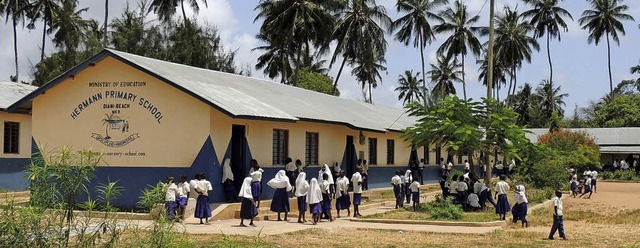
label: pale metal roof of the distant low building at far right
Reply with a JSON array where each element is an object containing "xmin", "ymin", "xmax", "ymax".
[{"xmin": 527, "ymin": 127, "xmax": 640, "ymax": 146}]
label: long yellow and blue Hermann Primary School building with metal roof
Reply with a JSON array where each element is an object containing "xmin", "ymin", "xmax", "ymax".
[{"xmin": 6, "ymin": 49, "xmax": 476, "ymax": 206}]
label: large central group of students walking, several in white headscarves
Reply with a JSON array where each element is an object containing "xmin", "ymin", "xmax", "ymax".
[{"xmin": 239, "ymin": 163, "xmax": 364, "ymax": 226}]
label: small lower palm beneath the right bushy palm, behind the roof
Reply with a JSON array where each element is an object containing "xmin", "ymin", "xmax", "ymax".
[{"xmin": 351, "ymin": 44, "xmax": 387, "ymax": 103}]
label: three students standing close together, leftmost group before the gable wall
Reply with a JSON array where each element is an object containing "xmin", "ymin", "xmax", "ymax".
[{"xmin": 164, "ymin": 173, "xmax": 213, "ymax": 225}]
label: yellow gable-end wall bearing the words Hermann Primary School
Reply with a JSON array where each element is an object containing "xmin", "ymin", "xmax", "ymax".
[{"xmin": 33, "ymin": 57, "xmax": 210, "ymax": 167}]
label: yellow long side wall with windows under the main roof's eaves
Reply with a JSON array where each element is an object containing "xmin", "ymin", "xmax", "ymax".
[{"xmin": 210, "ymin": 109, "xmax": 422, "ymax": 167}]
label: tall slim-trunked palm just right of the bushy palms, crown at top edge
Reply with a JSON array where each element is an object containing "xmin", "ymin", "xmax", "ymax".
[{"xmin": 391, "ymin": 0, "xmax": 448, "ymax": 105}]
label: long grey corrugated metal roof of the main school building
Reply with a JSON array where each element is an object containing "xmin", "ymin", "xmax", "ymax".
[{"xmin": 109, "ymin": 50, "xmax": 416, "ymax": 131}]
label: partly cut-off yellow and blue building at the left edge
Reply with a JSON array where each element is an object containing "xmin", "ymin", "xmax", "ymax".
[{"xmin": 0, "ymin": 82, "xmax": 37, "ymax": 191}]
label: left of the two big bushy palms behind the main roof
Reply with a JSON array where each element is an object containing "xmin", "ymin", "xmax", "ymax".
[{"xmin": 255, "ymin": 0, "xmax": 334, "ymax": 85}]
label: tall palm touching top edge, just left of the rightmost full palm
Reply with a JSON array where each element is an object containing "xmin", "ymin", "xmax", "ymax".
[{"xmin": 522, "ymin": 0, "xmax": 573, "ymax": 91}]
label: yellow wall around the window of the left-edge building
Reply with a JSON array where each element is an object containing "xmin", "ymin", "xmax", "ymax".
[{"xmin": 0, "ymin": 111, "xmax": 31, "ymax": 158}]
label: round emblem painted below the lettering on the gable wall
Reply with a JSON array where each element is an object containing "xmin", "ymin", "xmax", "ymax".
[{"xmin": 91, "ymin": 113, "xmax": 140, "ymax": 147}]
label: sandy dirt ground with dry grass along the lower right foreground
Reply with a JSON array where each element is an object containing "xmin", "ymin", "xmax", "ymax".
[{"xmin": 192, "ymin": 182, "xmax": 640, "ymax": 248}]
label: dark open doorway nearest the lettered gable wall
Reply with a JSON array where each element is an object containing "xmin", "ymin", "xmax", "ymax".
[{"xmin": 231, "ymin": 125, "xmax": 249, "ymax": 195}]
